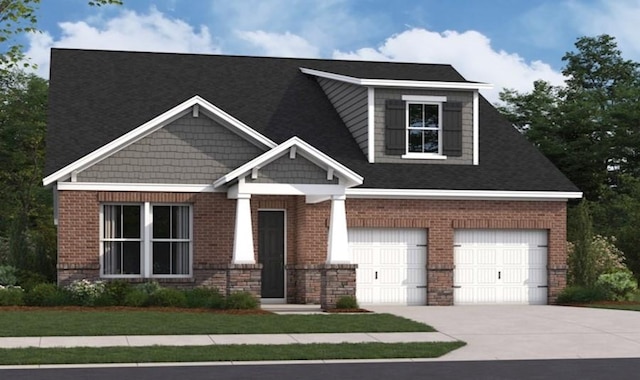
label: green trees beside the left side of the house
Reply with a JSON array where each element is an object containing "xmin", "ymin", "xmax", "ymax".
[{"xmin": 0, "ymin": 72, "xmax": 55, "ymax": 275}]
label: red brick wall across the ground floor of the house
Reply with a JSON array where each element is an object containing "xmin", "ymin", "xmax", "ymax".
[{"xmin": 58, "ymin": 191, "xmax": 566, "ymax": 304}]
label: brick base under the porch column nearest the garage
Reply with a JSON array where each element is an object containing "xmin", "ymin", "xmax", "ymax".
[{"xmin": 320, "ymin": 264, "xmax": 358, "ymax": 309}]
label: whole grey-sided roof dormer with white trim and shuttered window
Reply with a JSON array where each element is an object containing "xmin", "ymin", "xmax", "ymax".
[{"xmin": 300, "ymin": 68, "xmax": 492, "ymax": 165}]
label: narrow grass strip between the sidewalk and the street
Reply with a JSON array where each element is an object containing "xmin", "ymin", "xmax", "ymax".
[{"xmin": 0, "ymin": 342, "xmax": 465, "ymax": 365}]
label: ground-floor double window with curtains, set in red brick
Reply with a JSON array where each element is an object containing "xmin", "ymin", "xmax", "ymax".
[{"xmin": 102, "ymin": 203, "xmax": 192, "ymax": 277}]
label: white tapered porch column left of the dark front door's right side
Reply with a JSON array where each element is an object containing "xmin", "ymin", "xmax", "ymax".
[{"xmin": 233, "ymin": 194, "xmax": 256, "ymax": 264}]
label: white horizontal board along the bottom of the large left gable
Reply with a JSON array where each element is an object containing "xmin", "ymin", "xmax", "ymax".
[{"xmin": 57, "ymin": 182, "xmax": 224, "ymax": 193}]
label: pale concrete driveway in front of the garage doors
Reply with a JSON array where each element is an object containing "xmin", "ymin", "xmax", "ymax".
[{"xmin": 367, "ymin": 306, "xmax": 640, "ymax": 360}]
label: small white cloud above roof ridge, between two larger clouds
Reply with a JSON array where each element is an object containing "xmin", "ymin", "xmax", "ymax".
[{"xmin": 238, "ymin": 30, "xmax": 320, "ymax": 58}]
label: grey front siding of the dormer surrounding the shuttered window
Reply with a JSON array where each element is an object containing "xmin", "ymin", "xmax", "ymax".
[{"xmin": 374, "ymin": 88, "xmax": 473, "ymax": 165}]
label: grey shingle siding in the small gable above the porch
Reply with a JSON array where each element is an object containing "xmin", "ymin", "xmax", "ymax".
[{"xmin": 246, "ymin": 155, "xmax": 338, "ymax": 184}]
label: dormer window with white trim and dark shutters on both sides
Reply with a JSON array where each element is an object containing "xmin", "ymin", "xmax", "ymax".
[{"xmin": 385, "ymin": 95, "xmax": 462, "ymax": 159}]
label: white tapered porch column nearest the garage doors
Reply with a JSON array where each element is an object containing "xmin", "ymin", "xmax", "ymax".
[{"xmin": 327, "ymin": 195, "xmax": 351, "ymax": 264}]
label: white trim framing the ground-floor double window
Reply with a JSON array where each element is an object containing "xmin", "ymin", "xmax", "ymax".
[{"xmin": 100, "ymin": 202, "xmax": 193, "ymax": 279}]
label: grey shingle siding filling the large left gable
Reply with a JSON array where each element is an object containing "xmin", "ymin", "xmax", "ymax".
[{"xmin": 77, "ymin": 114, "xmax": 264, "ymax": 184}]
